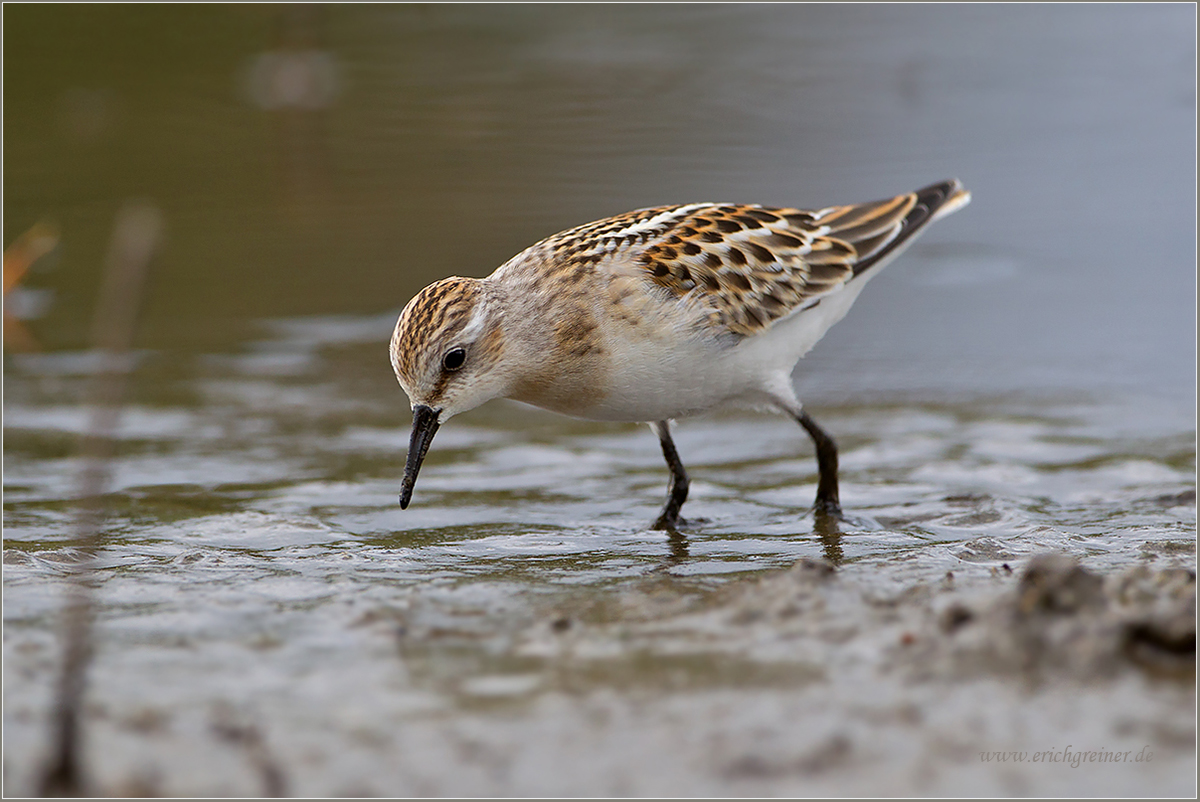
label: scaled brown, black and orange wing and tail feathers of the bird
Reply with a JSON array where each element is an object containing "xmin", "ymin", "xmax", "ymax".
[{"xmin": 529, "ymin": 180, "xmax": 966, "ymax": 337}]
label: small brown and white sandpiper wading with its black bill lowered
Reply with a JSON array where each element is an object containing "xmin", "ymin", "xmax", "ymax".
[{"xmin": 390, "ymin": 180, "xmax": 971, "ymax": 531}]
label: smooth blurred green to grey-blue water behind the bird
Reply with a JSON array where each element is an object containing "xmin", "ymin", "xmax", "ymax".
[{"xmin": 4, "ymin": 4, "xmax": 1195, "ymax": 391}]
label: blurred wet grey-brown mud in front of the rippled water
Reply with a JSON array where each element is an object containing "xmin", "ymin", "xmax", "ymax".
[{"xmin": 5, "ymin": 543, "xmax": 1195, "ymax": 796}]
